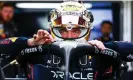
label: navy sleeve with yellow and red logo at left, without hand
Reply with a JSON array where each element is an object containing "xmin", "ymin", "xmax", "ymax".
[{"xmin": 0, "ymin": 37, "xmax": 29, "ymax": 54}]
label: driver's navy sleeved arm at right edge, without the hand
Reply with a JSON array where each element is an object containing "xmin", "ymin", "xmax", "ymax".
[{"xmin": 104, "ymin": 41, "xmax": 133, "ymax": 61}]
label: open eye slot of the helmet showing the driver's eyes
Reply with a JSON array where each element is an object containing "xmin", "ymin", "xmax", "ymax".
[{"xmin": 52, "ymin": 27, "xmax": 89, "ymax": 39}]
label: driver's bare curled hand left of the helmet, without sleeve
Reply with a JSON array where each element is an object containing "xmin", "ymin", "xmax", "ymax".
[{"xmin": 28, "ymin": 29, "xmax": 54, "ymax": 46}]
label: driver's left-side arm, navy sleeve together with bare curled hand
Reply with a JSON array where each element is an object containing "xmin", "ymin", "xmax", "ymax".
[{"xmin": 0, "ymin": 30, "xmax": 53, "ymax": 54}]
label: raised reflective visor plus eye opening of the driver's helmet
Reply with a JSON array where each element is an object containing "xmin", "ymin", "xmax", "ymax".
[{"xmin": 52, "ymin": 15, "xmax": 90, "ymax": 39}]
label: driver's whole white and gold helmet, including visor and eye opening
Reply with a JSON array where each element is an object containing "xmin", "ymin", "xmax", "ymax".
[{"xmin": 49, "ymin": 1, "xmax": 93, "ymax": 40}]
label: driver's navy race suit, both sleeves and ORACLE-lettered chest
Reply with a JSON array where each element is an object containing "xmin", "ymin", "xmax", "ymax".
[{"xmin": 0, "ymin": 37, "xmax": 133, "ymax": 80}]
